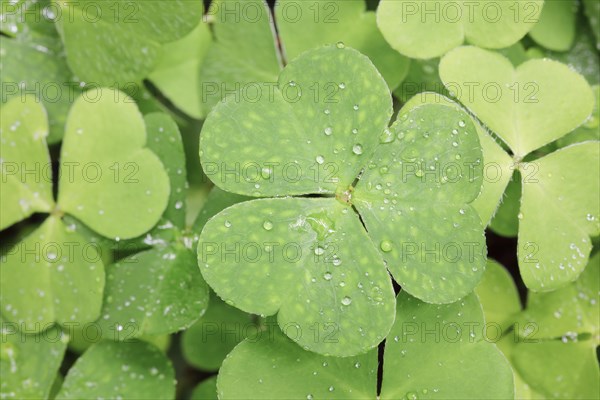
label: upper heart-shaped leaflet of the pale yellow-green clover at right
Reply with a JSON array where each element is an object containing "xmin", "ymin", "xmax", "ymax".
[{"xmin": 440, "ymin": 46, "xmax": 594, "ymax": 159}]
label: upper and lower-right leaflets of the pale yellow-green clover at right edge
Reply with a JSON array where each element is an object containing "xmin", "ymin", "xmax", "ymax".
[{"xmin": 440, "ymin": 47, "xmax": 600, "ymax": 291}]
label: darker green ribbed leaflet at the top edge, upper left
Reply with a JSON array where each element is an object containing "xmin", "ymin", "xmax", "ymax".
[{"xmin": 57, "ymin": 0, "xmax": 202, "ymax": 87}]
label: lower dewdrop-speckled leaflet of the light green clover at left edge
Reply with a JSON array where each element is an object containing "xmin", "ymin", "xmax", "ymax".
[{"xmin": 0, "ymin": 216, "xmax": 104, "ymax": 332}]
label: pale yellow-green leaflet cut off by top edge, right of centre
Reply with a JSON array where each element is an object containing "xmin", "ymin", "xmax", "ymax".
[{"xmin": 377, "ymin": 0, "xmax": 544, "ymax": 58}]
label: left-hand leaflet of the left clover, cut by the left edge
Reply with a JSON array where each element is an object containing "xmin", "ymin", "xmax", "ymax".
[{"xmin": 0, "ymin": 96, "xmax": 54, "ymax": 229}]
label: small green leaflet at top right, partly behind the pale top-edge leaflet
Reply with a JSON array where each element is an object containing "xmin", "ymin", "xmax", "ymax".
[{"xmin": 529, "ymin": 0, "xmax": 578, "ymax": 51}]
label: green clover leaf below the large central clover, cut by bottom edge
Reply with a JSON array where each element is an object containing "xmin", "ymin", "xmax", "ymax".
[{"xmin": 217, "ymin": 293, "xmax": 514, "ymax": 399}]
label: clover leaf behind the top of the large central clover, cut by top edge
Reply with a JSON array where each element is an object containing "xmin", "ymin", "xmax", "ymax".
[{"xmin": 201, "ymin": 0, "xmax": 408, "ymax": 110}]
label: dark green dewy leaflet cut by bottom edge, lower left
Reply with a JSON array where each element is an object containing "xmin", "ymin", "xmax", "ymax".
[{"xmin": 56, "ymin": 341, "xmax": 175, "ymax": 400}]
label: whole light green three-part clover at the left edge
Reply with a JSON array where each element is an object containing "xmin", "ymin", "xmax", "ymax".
[{"xmin": 0, "ymin": 90, "xmax": 169, "ymax": 332}]
